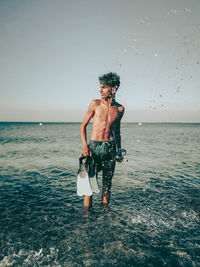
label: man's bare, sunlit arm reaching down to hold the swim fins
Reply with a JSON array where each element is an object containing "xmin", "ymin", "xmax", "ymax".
[{"xmin": 80, "ymin": 100, "xmax": 96, "ymax": 157}]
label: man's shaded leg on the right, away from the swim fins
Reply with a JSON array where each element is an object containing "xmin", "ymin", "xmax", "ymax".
[{"xmin": 102, "ymin": 162, "xmax": 115, "ymax": 207}]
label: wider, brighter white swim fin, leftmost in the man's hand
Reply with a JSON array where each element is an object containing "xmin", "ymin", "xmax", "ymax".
[{"xmin": 77, "ymin": 157, "xmax": 92, "ymax": 196}]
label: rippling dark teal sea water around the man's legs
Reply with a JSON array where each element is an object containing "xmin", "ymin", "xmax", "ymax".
[{"xmin": 0, "ymin": 123, "xmax": 200, "ymax": 267}]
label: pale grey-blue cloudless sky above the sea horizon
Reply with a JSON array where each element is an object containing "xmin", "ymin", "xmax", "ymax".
[{"xmin": 0, "ymin": 0, "xmax": 200, "ymax": 122}]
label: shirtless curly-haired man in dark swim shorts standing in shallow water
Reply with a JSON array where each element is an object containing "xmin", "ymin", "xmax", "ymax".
[{"xmin": 80, "ymin": 72, "xmax": 124, "ymax": 210}]
